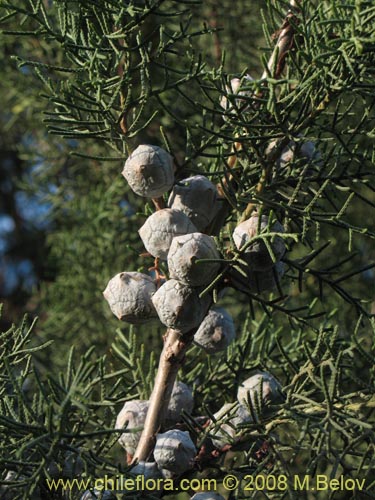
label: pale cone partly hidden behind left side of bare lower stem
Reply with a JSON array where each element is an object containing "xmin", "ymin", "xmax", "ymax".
[{"xmin": 115, "ymin": 399, "xmax": 149, "ymax": 455}]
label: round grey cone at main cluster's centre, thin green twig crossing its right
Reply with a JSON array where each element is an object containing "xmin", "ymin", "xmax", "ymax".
[{"xmin": 168, "ymin": 233, "xmax": 220, "ymax": 286}]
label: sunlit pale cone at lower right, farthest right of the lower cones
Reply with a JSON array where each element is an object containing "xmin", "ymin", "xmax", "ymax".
[{"xmin": 237, "ymin": 372, "xmax": 284, "ymax": 414}]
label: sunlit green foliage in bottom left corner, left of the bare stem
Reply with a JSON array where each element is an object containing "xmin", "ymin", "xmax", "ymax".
[{"xmin": 0, "ymin": 312, "xmax": 159, "ymax": 498}]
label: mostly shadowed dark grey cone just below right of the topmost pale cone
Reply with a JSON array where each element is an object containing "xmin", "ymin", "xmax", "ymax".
[{"xmin": 168, "ymin": 175, "xmax": 219, "ymax": 231}]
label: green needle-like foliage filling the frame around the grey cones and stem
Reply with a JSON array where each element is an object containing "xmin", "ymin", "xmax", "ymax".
[{"xmin": 0, "ymin": 0, "xmax": 375, "ymax": 498}]
